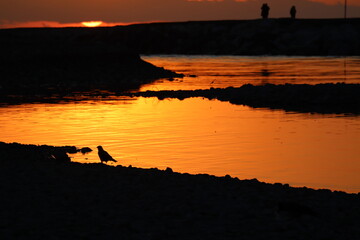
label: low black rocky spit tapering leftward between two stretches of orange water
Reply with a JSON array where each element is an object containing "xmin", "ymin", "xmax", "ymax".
[{"xmin": 126, "ymin": 83, "xmax": 360, "ymax": 114}]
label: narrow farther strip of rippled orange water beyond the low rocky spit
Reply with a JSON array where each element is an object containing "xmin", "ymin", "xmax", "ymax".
[{"xmin": 141, "ymin": 55, "xmax": 360, "ymax": 90}]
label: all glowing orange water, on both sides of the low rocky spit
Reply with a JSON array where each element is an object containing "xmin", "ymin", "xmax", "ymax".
[{"xmin": 0, "ymin": 56, "xmax": 360, "ymax": 192}]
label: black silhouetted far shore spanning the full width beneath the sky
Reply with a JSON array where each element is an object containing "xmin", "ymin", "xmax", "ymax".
[{"xmin": 0, "ymin": 18, "xmax": 360, "ymax": 102}]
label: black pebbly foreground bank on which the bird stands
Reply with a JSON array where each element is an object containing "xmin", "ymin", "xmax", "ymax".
[{"xmin": 0, "ymin": 143, "xmax": 360, "ymax": 240}]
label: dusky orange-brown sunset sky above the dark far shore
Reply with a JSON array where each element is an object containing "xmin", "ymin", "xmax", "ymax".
[{"xmin": 0, "ymin": 0, "xmax": 360, "ymax": 28}]
